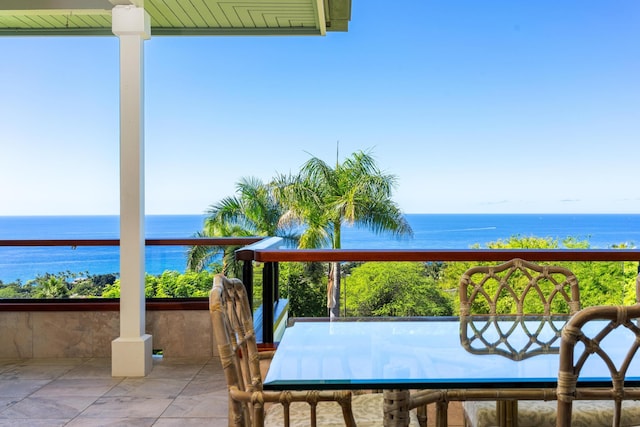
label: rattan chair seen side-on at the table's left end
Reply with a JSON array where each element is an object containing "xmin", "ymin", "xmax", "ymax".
[{"xmin": 209, "ymin": 275, "xmax": 410, "ymax": 427}]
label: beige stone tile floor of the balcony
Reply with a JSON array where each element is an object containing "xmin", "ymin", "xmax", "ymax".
[{"xmin": 0, "ymin": 358, "xmax": 462, "ymax": 427}]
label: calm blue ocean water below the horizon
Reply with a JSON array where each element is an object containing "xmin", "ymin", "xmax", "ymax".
[{"xmin": 0, "ymin": 214, "xmax": 640, "ymax": 283}]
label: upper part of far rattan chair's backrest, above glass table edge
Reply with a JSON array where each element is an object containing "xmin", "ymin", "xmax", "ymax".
[{"xmin": 459, "ymin": 258, "xmax": 580, "ymax": 316}]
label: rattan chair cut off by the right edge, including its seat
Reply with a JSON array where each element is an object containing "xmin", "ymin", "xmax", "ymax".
[{"xmin": 556, "ymin": 304, "xmax": 640, "ymax": 427}]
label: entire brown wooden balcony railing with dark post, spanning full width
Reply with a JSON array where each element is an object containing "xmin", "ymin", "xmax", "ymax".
[{"xmin": 0, "ymin": 237, "xmax": 640, "ymax": 350}]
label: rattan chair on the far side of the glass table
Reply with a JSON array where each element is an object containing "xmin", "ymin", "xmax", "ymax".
[{"xmin": 456, "ymin": 258, "xmax": 580, "ymax": 427}]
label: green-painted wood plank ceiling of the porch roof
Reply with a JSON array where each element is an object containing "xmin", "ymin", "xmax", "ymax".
[{"xmin": 0, "ymin": 0, "xmax": 351, "ymax": 36}]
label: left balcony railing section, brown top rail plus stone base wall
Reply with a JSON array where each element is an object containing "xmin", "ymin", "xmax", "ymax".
[{"xmin": 0, "ymin": 237, "xmax": 261, "ymax": 358}]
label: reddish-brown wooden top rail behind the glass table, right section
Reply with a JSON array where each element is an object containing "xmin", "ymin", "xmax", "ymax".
[{"xmin": 242, "ymin": 249, "xmax": 640, "ymax": 262}]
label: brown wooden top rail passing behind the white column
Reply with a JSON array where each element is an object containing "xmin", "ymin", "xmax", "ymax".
[{"xmin": 0, "ymin": 237, "xmax": 264, "ymax": 246}]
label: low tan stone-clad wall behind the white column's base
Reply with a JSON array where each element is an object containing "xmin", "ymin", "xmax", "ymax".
[{"xmin": 0, "ymin": 310, "xmax": 218, "ymax": 359}]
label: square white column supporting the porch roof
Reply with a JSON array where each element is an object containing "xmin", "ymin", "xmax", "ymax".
[{"xmin": 111, "ymin": 6, "xmax": 153, "ymax": 377}]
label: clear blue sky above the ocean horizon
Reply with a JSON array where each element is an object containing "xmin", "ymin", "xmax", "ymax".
[{"xmin": 0, "ymin": 0, "xmax": 640, "ymax": 215}]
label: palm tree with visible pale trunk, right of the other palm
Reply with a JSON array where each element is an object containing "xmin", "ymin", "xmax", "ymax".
[{"xmin": 274, "ymin": 151, "xmax": 413, "ymax": 317}]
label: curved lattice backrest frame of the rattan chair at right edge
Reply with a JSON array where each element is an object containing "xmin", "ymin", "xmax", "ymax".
[{"xmin": 557, "ymin": 304, "xmax": 640, "ymax": 427}]
